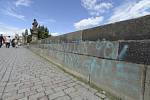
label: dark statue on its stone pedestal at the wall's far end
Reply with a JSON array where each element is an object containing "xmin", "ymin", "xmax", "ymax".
[{"xmin": 30, "ymin": 19, "xmax": 38, "ymax": 42}]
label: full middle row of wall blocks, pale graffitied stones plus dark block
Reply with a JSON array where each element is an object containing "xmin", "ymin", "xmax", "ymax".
[{"xmin": 39, "ymin": 40, "xmax": 150, "ymax": 65}]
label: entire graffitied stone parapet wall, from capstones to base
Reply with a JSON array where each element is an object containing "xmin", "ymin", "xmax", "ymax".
[{"xmin": 30, "ymin": 15, "xmax": 150, "ymax": 100}]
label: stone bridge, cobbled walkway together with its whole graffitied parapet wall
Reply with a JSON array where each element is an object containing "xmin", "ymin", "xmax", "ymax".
[{"xmin": 0, "ymin": 15, "xmax": 150, "ymax": 100}]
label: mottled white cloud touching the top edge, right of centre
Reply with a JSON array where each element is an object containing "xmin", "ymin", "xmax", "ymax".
[{"xmin": 81, "ymin": 0, "xmax": 113, "ymax": 16}]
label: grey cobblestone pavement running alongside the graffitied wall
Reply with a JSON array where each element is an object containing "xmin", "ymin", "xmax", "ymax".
[{"xmin": 0, "ymin": 48, "xmax": 108, "ymax": 100}]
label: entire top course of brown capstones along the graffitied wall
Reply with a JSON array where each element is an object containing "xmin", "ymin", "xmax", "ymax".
[{"xmin": 42, "ymin": 15, "xmax": 150, "ymax": 43}]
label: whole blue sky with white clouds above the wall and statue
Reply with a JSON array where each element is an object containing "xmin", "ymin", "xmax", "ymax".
[{"xmin": 0, "ymin": 0, "xmax": 150, "ymax": 36}]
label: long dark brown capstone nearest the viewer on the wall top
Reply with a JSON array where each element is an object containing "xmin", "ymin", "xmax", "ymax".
[{"xmin": 82, "ymin": 15, "xmax": 150, "ymax": 41}]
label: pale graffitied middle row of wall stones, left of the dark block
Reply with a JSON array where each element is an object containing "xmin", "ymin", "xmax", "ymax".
[{"xmin": 40, "ymin": 40, "xmax": 119, "ymax": 59}]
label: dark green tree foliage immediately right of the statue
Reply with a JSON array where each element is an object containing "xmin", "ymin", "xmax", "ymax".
[{"xmin": 38, "ymin": 26, "xmax": 49, "ymax": 39}]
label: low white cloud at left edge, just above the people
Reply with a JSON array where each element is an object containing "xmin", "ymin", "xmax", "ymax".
[{"xmin": 0, "ymin": 22, "xmax": 25, "ymax": 36}]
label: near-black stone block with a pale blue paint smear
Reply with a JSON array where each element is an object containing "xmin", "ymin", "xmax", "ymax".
[{"xmin": 118, "ymin": 41, "xmax": 150, "ymax": 65}]
